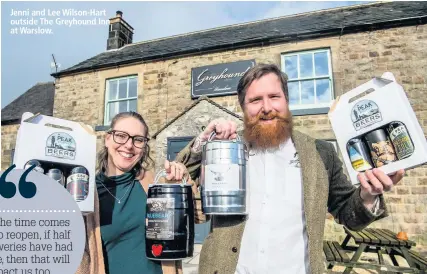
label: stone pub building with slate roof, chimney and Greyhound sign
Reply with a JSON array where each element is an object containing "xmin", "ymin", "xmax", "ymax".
[{"xmin": 1, "ymin": 2, "xmax": 427, "ymax": 256}]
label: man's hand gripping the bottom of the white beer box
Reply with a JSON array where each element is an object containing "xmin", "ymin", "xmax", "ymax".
[{"xmin": 357, "ymin": 168, "xmax": 405, "ymax": 209}]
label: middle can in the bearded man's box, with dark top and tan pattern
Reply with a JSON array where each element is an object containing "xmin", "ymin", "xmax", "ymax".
[{"xmin": 365, "ymin": 129, "xmax": 397, "ymax": 167}]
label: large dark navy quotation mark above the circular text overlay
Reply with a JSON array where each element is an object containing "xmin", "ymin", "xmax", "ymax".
[{"xmin": 0, "ymin": 165, "xmax": 37, "ymax": 199}]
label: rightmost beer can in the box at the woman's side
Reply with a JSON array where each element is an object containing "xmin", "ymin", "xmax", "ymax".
[{"xmin": 67, "ymin": 166, "xmax": 89, "ymax": 202}]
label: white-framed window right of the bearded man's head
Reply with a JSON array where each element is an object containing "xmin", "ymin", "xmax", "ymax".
[{"xmin": 282, "ymin": 49, "xmax": 334, "ymax": 110}]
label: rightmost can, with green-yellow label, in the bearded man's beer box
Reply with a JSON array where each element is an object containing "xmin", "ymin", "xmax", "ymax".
[{"xmin": 387, "ymin": 121, "xmax": 415, "ymax": 160}]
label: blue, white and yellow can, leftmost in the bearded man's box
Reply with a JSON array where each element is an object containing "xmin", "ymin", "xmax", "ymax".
[{"xmin": 347, "ymin": 138, "xmax": 373, "ymax": 171}]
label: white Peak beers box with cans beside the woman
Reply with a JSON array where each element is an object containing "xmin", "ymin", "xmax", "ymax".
[{"xmin": 13, "ymin": 112, "xmax": 96, "ymax": 214}]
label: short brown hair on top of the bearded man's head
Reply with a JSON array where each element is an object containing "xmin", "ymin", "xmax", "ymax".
[{"xmin": 237, "ymin": 64, "xmax": 289, "ymax": 109}]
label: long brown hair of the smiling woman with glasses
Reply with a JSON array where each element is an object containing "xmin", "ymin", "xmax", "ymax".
[{"xmin": 96, "ymin": 111, "xmax": 154, "ymax": 177}]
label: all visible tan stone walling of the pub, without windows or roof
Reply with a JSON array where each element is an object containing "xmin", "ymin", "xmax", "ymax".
[{"xmin": 2, "ymin": 25, "xmax": 427, "ymax": 248}]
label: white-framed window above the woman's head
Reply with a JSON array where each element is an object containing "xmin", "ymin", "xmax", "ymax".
[{"xmin": 104, "ymin": 76, "xmax": 138, "ymax": 125}]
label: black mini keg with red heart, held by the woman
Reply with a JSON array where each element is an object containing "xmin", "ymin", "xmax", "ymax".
[{"xmin": 145, "ymin": 170, "xmax": 194, "ymax": 260}]
